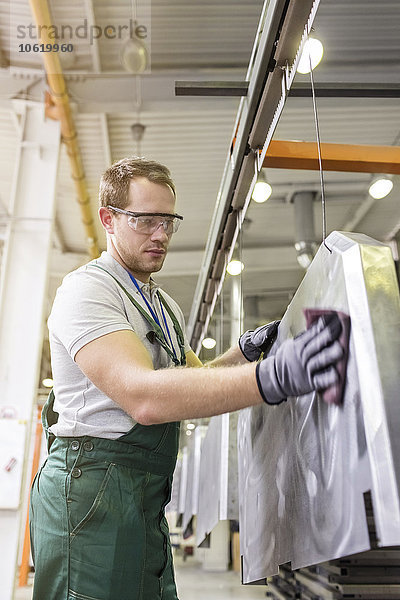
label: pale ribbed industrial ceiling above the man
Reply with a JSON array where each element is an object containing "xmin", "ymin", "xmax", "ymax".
[{"xmin": 0, "ymin": 0, "xmax": 400, "ymax": 376}]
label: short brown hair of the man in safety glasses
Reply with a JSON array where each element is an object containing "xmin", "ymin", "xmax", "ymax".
[{"xmin": 99, "ymin": 156, "xmax": 176, "ymax": 209}]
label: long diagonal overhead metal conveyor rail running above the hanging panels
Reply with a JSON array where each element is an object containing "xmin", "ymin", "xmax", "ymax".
[{"xmin": 188, "ymin": 0, "xmax": 319, "ymax": 349}]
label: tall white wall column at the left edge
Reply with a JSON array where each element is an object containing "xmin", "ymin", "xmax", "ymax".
[{"xmin": 0, "ymin": 101, "xmax": 60, "ymax": 600}]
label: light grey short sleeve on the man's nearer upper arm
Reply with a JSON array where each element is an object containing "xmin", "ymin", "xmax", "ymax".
[{"xmin": 48, "ymin": 269, "xmax": 133, "ymax": 359}]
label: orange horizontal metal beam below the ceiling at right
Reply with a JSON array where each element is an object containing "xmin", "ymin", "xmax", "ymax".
[{"xmin": 263, "ymin": 140, "xmax": 400, "ymax": 175}]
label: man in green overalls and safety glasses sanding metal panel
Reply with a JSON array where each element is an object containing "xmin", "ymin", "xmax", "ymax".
[{"xmin": 31, "ymin": 158, "xmax": 342, "ymax": 600}]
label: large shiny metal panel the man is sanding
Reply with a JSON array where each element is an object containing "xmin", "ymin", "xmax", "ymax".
[{"xmin": 238, "ymin": 232, "xmax": 400, "ymax": 583}]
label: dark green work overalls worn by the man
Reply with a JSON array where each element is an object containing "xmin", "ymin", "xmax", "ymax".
[{"xmin": 30, "ymin": 270, "xmax": 185, "ymax": 600}]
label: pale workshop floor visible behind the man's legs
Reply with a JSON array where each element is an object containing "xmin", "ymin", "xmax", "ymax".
[{"xmin": 15, "ymin": 558, "xmax": 266, "ymax": 600}]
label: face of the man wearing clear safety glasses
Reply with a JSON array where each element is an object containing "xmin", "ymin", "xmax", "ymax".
[{"xmin": 112, "ymin": 177, "xmax": 175, "ymax": 282}]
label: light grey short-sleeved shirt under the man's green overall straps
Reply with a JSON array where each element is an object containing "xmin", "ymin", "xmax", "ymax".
[{"xmin": 48, "ymin": 252, "xmax": 190, "ymax": 439}]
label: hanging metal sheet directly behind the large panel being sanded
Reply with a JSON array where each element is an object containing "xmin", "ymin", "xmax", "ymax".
[{"xmin": 196, "ymin": 413, "xmax": 239, "ymax": 545}]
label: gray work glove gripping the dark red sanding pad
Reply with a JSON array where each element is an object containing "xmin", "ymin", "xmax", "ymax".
[{"xmin": 256, "ymin": 315, "xmax": 343, "ymax": 404}]
